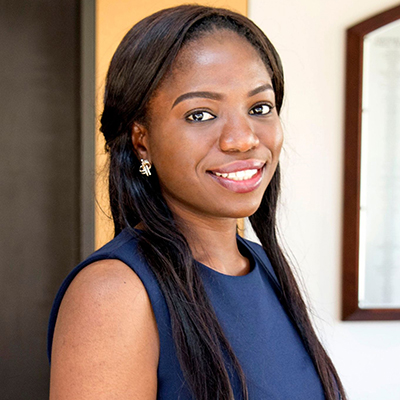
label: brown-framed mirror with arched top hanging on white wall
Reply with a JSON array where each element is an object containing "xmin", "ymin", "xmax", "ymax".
[{"xmin": 342, "ymin": 7, "xmax": 400, "ymax": 320}]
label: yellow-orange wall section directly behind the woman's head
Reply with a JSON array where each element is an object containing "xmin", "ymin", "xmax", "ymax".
[{"xmin": 95, "ymin": 0, "xmax": 247, "ymax": 248}]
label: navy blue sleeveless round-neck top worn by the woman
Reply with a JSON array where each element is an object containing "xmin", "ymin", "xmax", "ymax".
[{"xmin": 48, "ymin": 230, "xmax": 325, "ymax": 400}]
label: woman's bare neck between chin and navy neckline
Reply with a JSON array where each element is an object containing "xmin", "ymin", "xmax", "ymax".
[{"xmin": 174, "ymin": 206, "xmax": 250, "ymax": 275}]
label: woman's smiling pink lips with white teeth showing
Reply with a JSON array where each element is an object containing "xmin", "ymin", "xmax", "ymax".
[{"xmin": 207, "ymin": 160, "xmax": 265, "ymax": 193}]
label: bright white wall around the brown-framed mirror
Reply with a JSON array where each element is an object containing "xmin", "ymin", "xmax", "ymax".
[{"xmin": 249, "ymin": 0, "xmax": 400, "ymax": 400}]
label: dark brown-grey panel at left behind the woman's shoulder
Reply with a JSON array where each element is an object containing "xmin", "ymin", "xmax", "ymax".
[{"xmin": 0, "ymin": 0, "xmax": 81, "ymax": 400}]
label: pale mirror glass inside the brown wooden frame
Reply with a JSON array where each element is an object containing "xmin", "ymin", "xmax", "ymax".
[{"xmin": 359, "ymin": 21, "xmax": 400, "ymax": 308}]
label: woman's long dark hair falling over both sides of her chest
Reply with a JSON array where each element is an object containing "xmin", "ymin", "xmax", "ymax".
[{"xmin": 101, "ymin": 5, "xmax": 345, "ymax": 400}]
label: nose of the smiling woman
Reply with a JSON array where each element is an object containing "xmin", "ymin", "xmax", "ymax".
[{"xmin": 219, "ymin": 117, "xmax": 260, "ymax": 152}]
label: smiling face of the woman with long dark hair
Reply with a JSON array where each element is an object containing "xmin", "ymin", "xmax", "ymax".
[{"xmin": 139, "ymin": 31, "xmax": 283, "ymax": 219}]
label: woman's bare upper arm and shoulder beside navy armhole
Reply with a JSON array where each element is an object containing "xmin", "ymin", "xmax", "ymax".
[{"xmin": 50, "ymin": 260, "xmax": 159, "ymax": 400}]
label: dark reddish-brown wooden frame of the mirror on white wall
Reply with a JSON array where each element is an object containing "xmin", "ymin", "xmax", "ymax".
[{"xmin": 342, "ymin": 6, "xmax": 400, "ymax": 320}]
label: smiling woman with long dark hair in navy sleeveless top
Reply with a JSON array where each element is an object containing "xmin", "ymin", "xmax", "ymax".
[{"xmin": 49, "ymin": 5, "xmax": 345, "ymax": 400}]
